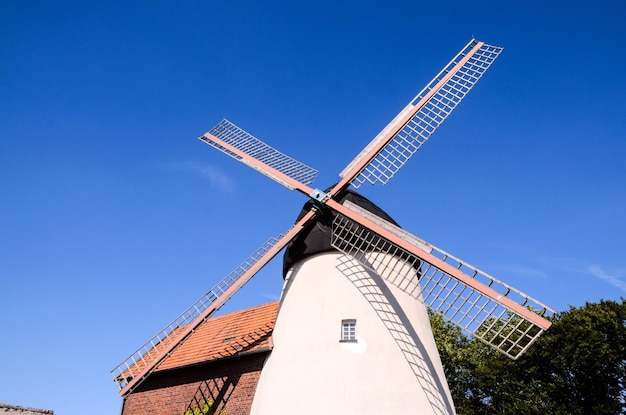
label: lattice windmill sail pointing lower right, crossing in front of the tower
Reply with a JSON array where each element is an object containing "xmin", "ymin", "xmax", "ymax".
[{"xmin": 331, "ymin": 201, "xmax": 554, "ymax": 359}]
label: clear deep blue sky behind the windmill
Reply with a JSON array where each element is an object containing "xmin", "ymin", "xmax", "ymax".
[{"xmin": 0, "ymin": 0, "xmax": 626, "ymax": 415}]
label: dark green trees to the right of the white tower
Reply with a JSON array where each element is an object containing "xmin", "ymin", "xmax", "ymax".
[{"xmin": 431, "ymin": 299, "xmax": 626, "ymax": 415}]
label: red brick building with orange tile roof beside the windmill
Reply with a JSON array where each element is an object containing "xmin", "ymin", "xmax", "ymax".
[{"xmin": 122, "ymin": 302, "xmax": 278, "ymax": 415}]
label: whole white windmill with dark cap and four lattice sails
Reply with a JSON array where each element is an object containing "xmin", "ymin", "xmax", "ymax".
[{"xmin": 112, "ymin": 39, "xmax": 554, "ymax": 414}]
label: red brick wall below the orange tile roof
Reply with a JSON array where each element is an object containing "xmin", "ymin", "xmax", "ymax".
[{"xmin": 122, "ymin": 351, "xmax": 267, "ymax": 415}]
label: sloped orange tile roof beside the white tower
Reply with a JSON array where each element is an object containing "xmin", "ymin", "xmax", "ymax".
[{"xmin": 156, "ymin": 302, "xmax": 278, "ymax": 371}]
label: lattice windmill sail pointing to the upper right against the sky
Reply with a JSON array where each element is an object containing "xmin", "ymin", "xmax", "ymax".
[{"xmin": 340, "ymin": 39, "xmax": 503, "ymax": 188}]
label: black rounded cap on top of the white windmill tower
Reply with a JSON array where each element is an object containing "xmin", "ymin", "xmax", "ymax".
[{"xmin": 283, "ymin": 189, "xmax": 399, "ymax": 278}]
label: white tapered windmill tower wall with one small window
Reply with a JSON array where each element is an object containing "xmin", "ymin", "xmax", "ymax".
[{"xmin": 251, "ymin": 253, "xmax": 454, "ymax": 415}]
